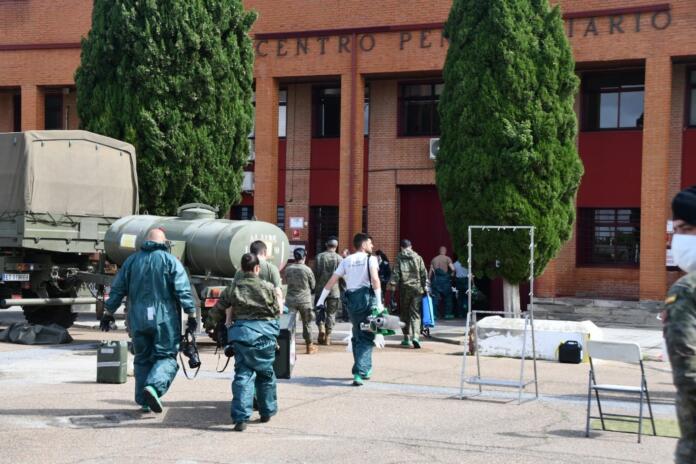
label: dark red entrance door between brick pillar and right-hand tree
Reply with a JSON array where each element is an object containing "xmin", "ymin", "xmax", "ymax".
[{"xmin": 399, "ymin": 185, "xmax": 452, "ymax": 266}]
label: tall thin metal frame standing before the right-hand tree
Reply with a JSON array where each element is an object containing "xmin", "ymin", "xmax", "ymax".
[{"xmin": 459, "ymin": 226, "xmax": 539, "ymax": 404}]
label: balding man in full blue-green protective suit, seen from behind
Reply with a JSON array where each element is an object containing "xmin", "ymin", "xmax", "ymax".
[{"xmin": 101, "ymin": 229, "xmax": 196, "ymax": 413}]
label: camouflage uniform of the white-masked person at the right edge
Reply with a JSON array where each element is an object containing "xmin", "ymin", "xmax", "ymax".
[{"xmin": 664, "ymin": 272, "xmax": 696, "ymax": 464}]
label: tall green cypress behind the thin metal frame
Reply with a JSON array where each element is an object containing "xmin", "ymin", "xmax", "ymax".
[{"xmin": 436, "ymin": 0, "xmax": 583, "ymax": 312}]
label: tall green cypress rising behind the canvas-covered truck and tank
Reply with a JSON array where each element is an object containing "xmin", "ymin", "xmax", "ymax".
[{"xmin": 75, "ymin": 0, "xmax": 256, "ymax": 214}]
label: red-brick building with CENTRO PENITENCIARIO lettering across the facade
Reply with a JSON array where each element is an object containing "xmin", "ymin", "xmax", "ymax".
[{"xmin": 0, "ymin": 0, "xmax": 696, "ymax": 300}]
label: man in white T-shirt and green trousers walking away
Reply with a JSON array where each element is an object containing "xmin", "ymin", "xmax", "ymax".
[{"xmin": 317, "ymin": 233, "xmax": 383, "ymax": 386}]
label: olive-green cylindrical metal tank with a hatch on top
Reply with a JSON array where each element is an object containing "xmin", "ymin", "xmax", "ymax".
[{"xmin": 104, "ymin": 203, "xmax": 290, "ymax": 277}]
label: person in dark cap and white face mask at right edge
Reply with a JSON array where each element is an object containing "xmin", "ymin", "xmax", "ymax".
[{"xmin": 662, "ymin": 186, "xmax": 696, "ymax": 464}]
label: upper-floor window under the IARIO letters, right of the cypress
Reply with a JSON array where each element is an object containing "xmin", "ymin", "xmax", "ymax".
[{"xmin": 582, "ymin": 71, "xmax": 645, "ymax": 131}]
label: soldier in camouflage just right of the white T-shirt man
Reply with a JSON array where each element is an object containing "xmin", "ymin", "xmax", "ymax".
[{"xmin": 389, "ymin": 239, "xmax": 428, "ymax": 348}]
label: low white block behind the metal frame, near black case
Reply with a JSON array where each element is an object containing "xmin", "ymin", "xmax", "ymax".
[{"xmin": 477, "ymin": 316, "xmax": 602, "ymax": 361}]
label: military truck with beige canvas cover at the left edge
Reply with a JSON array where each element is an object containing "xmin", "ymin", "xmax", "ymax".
[{"xmin": 0, "ymin": 131, "xmax": 138, "ymax": 328}]
